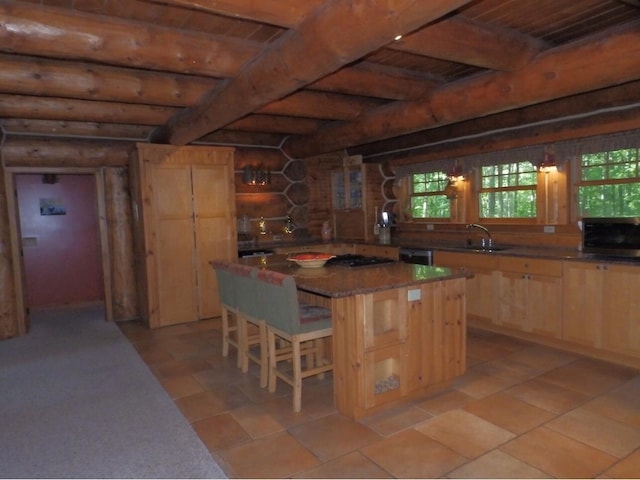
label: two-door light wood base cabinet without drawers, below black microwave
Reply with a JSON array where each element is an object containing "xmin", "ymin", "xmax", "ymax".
[{"xmin": 563, "ymin": 262, "xmax": 640, "ymax": 357}]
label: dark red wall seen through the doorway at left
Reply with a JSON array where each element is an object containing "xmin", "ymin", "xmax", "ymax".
[{"xmin": 16, "ymin": 174, "xmax": 104, "ymax": 308}]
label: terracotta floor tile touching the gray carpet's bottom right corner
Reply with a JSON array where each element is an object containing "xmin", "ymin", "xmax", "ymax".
[{"xmin": 220, "ymin": 432, "xmax": 319, "ymax": 478}]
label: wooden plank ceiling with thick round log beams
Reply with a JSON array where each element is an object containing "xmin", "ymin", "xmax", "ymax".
[{"xmin": 0, "ymin": 0, "xmax": 640, "ymax": 158}]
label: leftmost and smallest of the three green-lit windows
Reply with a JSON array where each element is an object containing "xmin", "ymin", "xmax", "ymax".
[{"xmin": 411, "ymin": 172, "xmax": 451, "ymax": 218}]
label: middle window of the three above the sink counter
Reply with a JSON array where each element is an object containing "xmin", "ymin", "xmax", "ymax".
[{"xmin": 479, "ymin": 162, "xmax": 538, "ymax": 218}]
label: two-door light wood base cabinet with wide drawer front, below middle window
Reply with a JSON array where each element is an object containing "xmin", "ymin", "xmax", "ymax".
[{"xmin": 496, "ymin": 257, "xmax": 562, "ymax": 338}]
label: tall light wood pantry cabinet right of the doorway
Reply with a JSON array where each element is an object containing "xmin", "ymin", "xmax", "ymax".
[{"xmin": 131, "ymin": 144, "xmax": 237, "ymax": 328}]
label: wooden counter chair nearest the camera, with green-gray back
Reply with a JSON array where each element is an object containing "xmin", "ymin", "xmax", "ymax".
[{"xmin": 257, "ymin": 270, "xmax": 333, "ymax": 412}]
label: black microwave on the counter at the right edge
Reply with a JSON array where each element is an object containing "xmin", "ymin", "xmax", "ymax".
[{"xmin": 582, "ymin": 217, "xmax": 640, "ymax": 257}]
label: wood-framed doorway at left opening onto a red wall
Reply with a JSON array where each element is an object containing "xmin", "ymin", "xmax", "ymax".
[{"xmin": 5, "ymin": 167, "xmax": 113, "ymax": 335}]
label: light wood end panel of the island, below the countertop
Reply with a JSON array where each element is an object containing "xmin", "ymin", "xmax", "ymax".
[{"xmin": 332, "ymin": 278, "xmax": 466, "ymax": 418}]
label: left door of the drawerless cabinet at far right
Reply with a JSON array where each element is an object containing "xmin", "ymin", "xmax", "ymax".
[{"xmin": 562, "ymin": 262, "xmax": 604, "ymax": 348}]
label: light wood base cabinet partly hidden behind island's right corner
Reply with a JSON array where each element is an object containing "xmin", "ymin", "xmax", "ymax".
[{"xmin": 434, "ymin": 250, "xmax": 498, "ymax": 325}]
